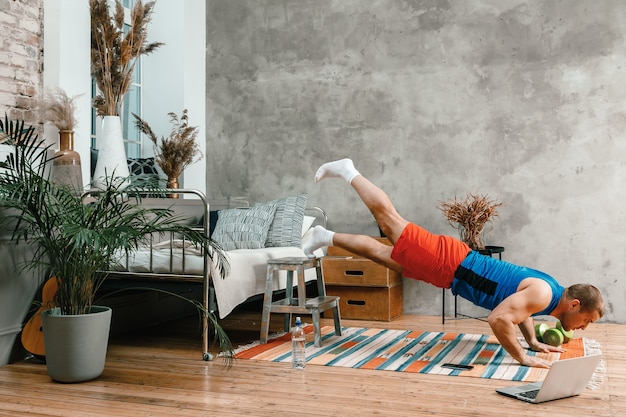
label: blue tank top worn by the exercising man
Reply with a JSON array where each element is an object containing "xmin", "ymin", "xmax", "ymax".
[{"xmin": 451, "ymin": 251, "xmax": 563, "ymax": 316}]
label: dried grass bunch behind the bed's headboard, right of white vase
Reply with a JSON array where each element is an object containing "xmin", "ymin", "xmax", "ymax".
[{"xmin": 133, "ymin": 109, "xmax": 202, "ymax": 183}]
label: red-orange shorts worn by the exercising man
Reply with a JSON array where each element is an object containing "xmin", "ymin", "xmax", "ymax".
[{"xmin": 391, "ymin": 223, "xmax": 471, "ymax": 288}]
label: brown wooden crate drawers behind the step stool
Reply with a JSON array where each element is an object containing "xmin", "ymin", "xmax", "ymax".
[{"xmin": 322, "ymin": 238, "xmax": 402, "ymax": 321}]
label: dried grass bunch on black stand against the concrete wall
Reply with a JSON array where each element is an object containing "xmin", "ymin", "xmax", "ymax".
[{"xmin": 439, "ymin": 193, "xmax": 502, "ymax": 250}]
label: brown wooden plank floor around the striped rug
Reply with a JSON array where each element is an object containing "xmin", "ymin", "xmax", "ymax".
[{"xmin": 0, "ymin": 315, "xmax": 626, "ymax": 417}]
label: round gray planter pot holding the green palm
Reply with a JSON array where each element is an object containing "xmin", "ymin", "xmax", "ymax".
[{"xmin": 41, "ymin": 306, "xmax": 111, "ymax": 382}]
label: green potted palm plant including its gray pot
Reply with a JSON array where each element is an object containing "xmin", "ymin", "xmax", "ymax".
[{"xmin": 0, "ymin": 117, "xmax": 232, "ymax": 382}]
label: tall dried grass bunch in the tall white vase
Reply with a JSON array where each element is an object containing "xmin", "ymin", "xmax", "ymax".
[{"xmin": 89, "ymin": 0, "xmax": 163, "ymax": 116}]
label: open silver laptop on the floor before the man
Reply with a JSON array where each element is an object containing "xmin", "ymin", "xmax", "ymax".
[{"xmin": 496, "ymin": 355, "xmax": 600, "ymax": 403}]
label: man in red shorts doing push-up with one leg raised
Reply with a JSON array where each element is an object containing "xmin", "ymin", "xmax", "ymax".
[{"xmin": 304, "ymin": 159, "xmax": 604, "ymax": 368}]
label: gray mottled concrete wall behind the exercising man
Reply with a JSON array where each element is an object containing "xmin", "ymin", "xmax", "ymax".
[{"xmin": 206, "ymin": 0, "xmax": 626, "ymax": 323}]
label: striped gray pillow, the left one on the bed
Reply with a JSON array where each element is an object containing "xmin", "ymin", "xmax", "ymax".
[{"xmin": 211, "ymin": 204, "xmax": 276, "ymax": 250}]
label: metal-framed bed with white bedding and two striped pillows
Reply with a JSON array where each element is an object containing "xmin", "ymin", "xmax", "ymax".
[{"xmin": 102, "ymin": 189, "xmax": 327, "ymax": 360}]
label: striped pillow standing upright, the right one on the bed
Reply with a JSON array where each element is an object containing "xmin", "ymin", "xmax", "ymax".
[{"xmin": 265, "ymin": 194, "xmax": 308, "ymax": 248}]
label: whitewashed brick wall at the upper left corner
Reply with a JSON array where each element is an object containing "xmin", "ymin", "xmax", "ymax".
[{"xmin": 0, "ymin": 0, "xmax": 43, "ymax": 123}]
